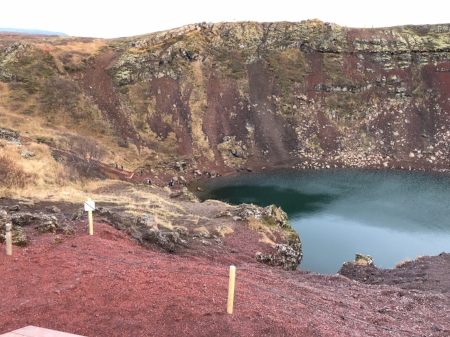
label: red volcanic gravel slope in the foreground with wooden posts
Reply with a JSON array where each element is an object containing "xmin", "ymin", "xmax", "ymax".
[{"xmin": 0, "ymin": 224, "xmax": 450, "ymax": 337}]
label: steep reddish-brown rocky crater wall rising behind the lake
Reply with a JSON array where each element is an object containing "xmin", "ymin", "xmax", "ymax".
[{"xmin": 0, "ymin": 20, "xmax": 450, "ymax": 176}]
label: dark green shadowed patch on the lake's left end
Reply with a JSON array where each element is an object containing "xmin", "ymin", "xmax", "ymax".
[{"xmin": 200, "ymin": 185, "xmax": 337, "ymax": 220}]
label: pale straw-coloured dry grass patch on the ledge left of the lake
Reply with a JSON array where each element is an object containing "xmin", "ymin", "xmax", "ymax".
[{"xmin": 0, "ymin": 154, "xmax": 199, "ymax": 230}]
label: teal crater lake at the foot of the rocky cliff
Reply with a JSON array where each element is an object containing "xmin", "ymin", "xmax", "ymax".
[{"xmin": 197, "ymin": 170, "xmax": 450, "ymax": 274}]
